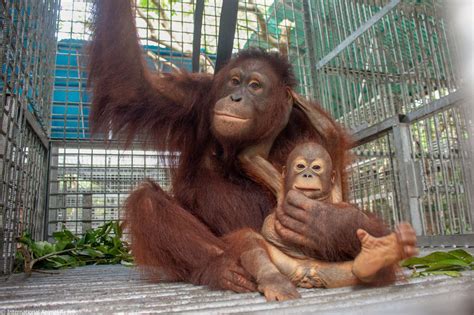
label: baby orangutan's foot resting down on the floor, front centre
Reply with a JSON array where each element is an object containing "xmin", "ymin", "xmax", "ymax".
[{"xmin": 258, "ymin": 273, "xmax": 301, "ymax": 301}]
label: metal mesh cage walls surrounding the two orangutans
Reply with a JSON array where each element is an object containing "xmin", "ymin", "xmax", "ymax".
[{"xmin": 0, "ymin": 0, "xmax": 474, "ymax": 273}]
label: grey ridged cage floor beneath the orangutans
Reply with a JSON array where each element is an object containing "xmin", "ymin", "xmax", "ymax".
[{"xmin": 0, "ymin": 265, "xmax": 474, "ymax": 315}]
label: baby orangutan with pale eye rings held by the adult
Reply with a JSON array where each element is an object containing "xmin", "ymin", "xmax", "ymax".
[{"xmin": 241, "ymin": 142, "xmax": 416, "ymax": 301}]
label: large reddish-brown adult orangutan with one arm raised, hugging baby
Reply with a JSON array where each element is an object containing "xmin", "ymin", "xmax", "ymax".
[{"xmin": 89, "ymin": 0, "xmax": 414, "ymax": 292}]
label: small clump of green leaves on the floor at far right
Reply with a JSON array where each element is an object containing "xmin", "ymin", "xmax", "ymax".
[{"xmin": 401, "ymin": 249, "xmax": 474, "ymax": 278}]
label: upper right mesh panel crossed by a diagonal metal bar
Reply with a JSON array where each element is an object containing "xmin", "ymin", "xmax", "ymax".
[{"xmin": 310, "ymin": 0, "xmax": 458, "ymax": 129}]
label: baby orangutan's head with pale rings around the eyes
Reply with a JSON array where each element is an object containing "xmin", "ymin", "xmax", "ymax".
[{"xmin": 284, "ymin": 142, "xmax": 335, "ymax": 200}]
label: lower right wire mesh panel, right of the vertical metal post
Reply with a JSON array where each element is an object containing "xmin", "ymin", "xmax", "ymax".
[{"xmin": 410, "ymin": 108, "xmax": 472, "ymax": 235}]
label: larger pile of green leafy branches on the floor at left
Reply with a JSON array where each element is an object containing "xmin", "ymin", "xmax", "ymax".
[{"xmin": 16, "ymin": 221, "xmax": 133, "ymax": 274}]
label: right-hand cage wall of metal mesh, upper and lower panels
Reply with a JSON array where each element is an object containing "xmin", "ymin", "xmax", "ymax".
[{"xmin": 308, "ymin": 0, "xmax": 473, "ymax": 235}]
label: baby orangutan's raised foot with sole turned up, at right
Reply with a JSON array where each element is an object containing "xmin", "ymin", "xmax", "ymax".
[{"xmin": 352, "ymin": 223, "xmax": 418, "ymax": 282}]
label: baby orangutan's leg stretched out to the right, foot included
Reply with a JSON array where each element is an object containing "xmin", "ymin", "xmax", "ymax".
[{"xmin": 267, "ymin": 224, "xmax": 416, "ymax": 288}]
